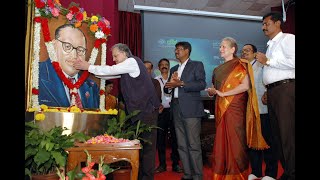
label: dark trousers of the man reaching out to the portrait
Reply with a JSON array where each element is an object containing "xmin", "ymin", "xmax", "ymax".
[{"xmin": 138, "ymin": 110, "xmax": 159, "ymax": 180}]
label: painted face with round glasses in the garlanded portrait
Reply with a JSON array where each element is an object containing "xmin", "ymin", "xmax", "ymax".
[{"xmin": 54, "ymin": 27, "xmax": 86, "ymax": 76}]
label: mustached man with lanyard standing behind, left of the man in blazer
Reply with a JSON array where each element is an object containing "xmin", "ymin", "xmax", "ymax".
[{"xmin": 155, "ymin": 58, "xmax": 182, "ymax": 173}]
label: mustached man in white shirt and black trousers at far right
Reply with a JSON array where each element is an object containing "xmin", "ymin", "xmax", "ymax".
[{"xmin": 256, "ymin": 12, "xmax": 295, "ymax": 180}]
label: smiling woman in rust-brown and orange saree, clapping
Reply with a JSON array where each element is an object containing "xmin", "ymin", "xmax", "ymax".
[{"xmin": 207, "ymin": 37, "xmax": 268, "ymax": 180}]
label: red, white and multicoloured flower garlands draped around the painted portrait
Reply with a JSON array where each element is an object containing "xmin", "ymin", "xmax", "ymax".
[{"xmin": 29, "ymin": 0, "xmax": 117, "ymax": 116}]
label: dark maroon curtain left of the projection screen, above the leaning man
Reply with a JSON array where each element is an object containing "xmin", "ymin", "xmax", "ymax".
[{"xmin": 119, "ymin": 11, "xmax": 142, "ymax": 58}]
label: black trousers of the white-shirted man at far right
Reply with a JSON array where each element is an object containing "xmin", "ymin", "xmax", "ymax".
[{"xmin": 267, "ymin": 82, "xmax": 296, "ymax": 180}]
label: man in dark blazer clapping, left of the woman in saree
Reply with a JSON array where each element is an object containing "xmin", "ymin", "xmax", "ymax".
[{"xmin": 164, "ymin": 42, "xmax": 206, "ymax": 180}]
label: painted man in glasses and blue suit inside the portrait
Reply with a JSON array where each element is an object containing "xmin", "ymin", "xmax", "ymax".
[{"xmin": 39, "ymin": 24, "xmax": 99, "ymax": 109}]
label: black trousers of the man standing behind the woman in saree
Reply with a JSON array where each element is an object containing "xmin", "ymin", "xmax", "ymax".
[{"xmin": 249, "ymin": 114, "xmax": 279, "ymax": 179}]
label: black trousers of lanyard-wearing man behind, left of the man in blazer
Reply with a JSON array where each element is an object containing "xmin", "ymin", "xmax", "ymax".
[{"xmin": 157, "ymin": 108, "xmax": 179, "ymax": 167}]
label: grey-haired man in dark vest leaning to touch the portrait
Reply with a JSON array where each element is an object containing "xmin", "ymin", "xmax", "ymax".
[{"xmin": 74, "ymin": 43, "xmax": 160, "ymax": 180}]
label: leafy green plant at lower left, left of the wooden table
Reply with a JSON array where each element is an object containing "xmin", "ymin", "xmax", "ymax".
[{"xmin": 25, "ymin": 121, "xmax": 89, "ymax": 179}]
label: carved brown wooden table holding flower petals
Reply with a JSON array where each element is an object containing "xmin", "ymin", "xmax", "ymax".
[{"xmin": 66, "ymin": 143, "xmax": 141, "ymax": 180}]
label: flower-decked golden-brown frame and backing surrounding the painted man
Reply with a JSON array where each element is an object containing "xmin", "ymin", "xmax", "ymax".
[{"xmin": 25, "ymin": 0, "xmax": 117, "ymax": 114}]
